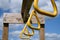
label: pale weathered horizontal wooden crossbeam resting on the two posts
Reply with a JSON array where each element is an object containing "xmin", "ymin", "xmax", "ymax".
[{"xmin": 3, "ymin": 13, "xmax": 45, "ymax": 24}]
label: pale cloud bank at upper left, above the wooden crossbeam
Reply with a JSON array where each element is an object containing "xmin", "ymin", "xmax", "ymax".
[{"xmin": 0, "ymin": 0, "xmax": 22, "ymax": 13}]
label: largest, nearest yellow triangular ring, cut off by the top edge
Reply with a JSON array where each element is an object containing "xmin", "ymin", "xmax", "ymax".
[{"xmin": 34, "ymin": 0, "xmax": 58, "ymax": 17}]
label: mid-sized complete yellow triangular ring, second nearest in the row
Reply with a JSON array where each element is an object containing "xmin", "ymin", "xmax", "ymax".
[{"xmin": 26, "ymin": 10, "xmax": 40, "ymax": 30}]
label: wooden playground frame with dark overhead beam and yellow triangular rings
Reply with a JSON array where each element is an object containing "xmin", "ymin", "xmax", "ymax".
[{"xmin": 3, "ymin": 0, "xmax": 58, "ymax": 40}]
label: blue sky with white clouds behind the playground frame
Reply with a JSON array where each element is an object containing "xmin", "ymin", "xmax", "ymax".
[{"xmin": 0, "ymin": 0, "xmax": 60, "ymax": 40}]
